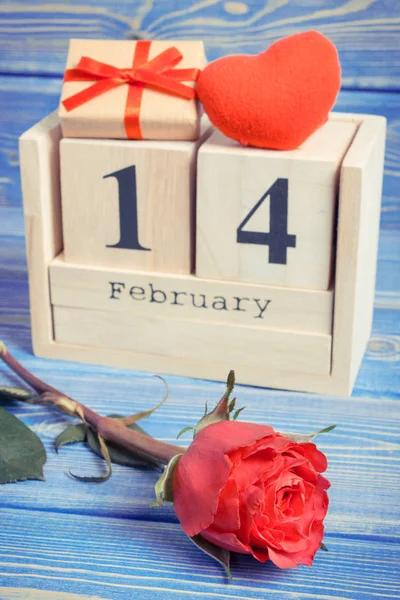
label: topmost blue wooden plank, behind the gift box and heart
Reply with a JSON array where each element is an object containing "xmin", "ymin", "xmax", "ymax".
[{"xmin": 0, "ymin": 0, "xmax": 400, "ymax": 89}]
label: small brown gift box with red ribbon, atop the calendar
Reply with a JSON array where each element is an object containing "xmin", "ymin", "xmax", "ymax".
[{"xmin": 59, "ymin": 40, "xmax": 206, "ymax": 140}]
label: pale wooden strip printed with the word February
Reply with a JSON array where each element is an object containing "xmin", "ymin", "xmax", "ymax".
[{"xmin": 49, "ymin": 254, "xmax": 334, "ymax": 334}]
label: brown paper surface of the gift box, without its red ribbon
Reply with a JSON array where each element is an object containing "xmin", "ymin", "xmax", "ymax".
[{"xmin": 59, "ymin": 40, "xmax": 207, "ymax": 140}]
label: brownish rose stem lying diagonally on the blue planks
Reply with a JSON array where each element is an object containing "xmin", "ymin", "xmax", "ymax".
[{"xmin": 0, "ymin": 342, "xmax": 185, "ymax": 464}]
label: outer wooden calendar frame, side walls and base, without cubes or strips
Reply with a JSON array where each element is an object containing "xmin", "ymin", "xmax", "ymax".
[{"xmin": 20, "ymin": 113, "xmax": 386, "ymax": 396}]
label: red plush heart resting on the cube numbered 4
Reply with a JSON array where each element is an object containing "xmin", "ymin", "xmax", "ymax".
[{"xmin": 196, "ymin": 31, "xmax": 341, "ymax": 150}]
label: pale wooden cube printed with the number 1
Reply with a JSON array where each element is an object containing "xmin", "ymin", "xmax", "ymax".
[{"xmin": 60, "ymin": 139, "xmax": 198, "ymax": 274}]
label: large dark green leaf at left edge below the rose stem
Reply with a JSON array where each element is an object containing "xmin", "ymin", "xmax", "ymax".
[{"xmin": 0, "ymin": 407, "xmax": 46, "ymax": 483}]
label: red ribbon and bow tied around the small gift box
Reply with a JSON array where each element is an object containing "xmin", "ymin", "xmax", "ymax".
[{"xmin": 63, "ymin": 40, "xmax": 200, "ymax": 139}]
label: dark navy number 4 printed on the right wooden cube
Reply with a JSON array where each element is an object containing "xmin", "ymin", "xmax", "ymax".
[{"xmin": 236, "ymin": 178, "xmax": 296, "ymax": 265}]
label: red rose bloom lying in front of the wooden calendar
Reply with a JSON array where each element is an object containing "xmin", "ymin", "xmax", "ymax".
[{"xmin": 173, "ymin": 421, "xmax": 330, "ymax": 568}]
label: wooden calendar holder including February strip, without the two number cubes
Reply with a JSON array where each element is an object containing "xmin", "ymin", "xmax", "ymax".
[{"xmin": 20, "ymin": 114, "xmax": 385, "ymax": 394}]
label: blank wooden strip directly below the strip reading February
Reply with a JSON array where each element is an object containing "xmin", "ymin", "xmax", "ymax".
[{"xmin": 51, "ymin": 301, "xmax": 332, "ymax": 376}]
